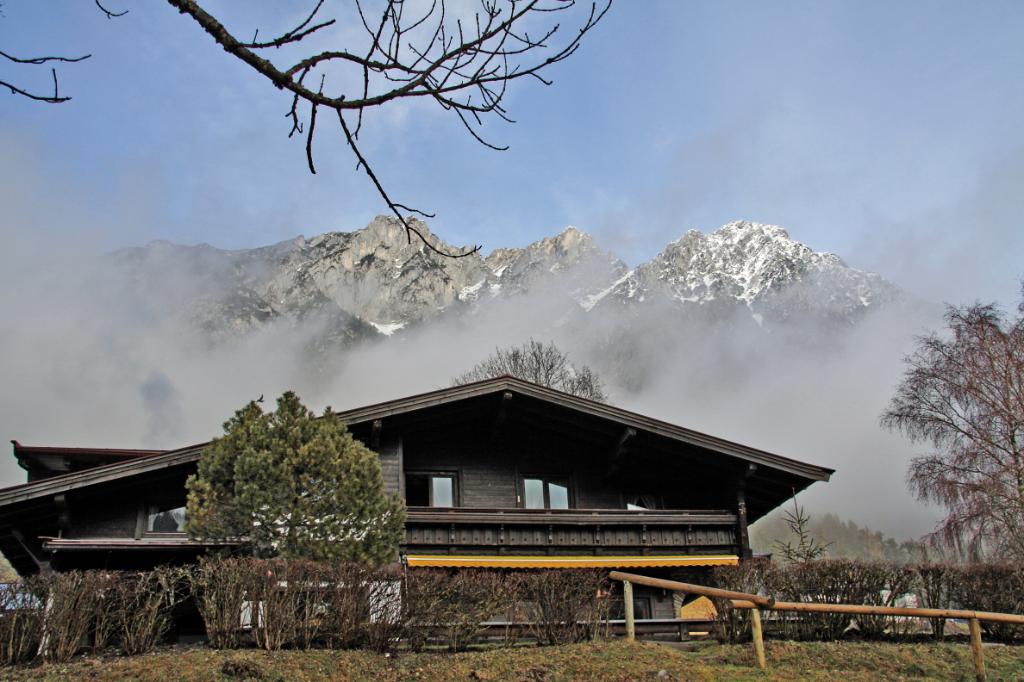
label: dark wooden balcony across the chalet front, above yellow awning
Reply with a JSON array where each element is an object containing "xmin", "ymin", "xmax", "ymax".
[{"xmin": 402, "ymin": 507, "xmax": 739, "ymax": 555}]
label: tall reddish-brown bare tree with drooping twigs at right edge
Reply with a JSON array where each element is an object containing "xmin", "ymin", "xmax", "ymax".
[{"xmin": 882, "ymin": 290, "xmax": 1024, "ymax": 559}]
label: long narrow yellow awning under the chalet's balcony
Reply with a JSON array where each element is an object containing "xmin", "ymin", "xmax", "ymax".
[{"xmin": 406, "ymin": 554, "xmax": 739, "ymax": 568}]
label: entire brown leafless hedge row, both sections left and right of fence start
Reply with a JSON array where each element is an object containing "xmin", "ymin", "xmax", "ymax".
[{"xmin": 16, "ymin": 558, "xmax": 1024, "ymax": 665}]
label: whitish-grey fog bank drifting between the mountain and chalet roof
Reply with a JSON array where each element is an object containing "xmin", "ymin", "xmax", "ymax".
[{"xmin": 0, "ymin": 137, "xmax": 941, "ymax": 539}]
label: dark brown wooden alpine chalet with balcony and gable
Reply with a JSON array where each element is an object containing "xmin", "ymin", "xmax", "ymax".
[{"xmin": 0, "ymin": 377, "xmax": 833, "ymax": 619}]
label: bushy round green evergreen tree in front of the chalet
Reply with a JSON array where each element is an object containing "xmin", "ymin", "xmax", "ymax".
[{"xmin": 185, "ymin": 391, "xmax": 406, "ymax": 564}]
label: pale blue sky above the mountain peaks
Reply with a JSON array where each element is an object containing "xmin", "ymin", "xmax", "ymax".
[{"xmin": 0, "ymin": 0, "xmax": 1024, "ymax": 305}]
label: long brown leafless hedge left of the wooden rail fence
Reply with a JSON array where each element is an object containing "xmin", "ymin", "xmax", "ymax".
[{"xmin": 0, "ymin": 558, "xmax": 609, "ymax": 665}]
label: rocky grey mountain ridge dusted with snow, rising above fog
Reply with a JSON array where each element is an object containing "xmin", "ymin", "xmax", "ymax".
[{"xmin": 111, "ymin": 216, "xmax": 899, "ymax": 346}]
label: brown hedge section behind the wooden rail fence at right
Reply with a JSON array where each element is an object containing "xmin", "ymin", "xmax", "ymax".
[{"xmin": 712, "ymin": 559, "xmax": 1024, "ymax": 641}]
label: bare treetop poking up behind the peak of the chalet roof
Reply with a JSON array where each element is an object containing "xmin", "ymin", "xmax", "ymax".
[{"xmin": 452, "ymin": 339, "xmax": 608, "ymax": 402}]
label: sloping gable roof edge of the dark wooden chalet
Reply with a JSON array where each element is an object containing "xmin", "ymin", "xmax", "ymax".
[{"xmin": 0, "ymin": 376, "xmax": 835, "ymax": 506}]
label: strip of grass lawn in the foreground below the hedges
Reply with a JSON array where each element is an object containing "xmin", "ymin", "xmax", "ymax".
[{"xmin": 0, "ymin": 641, "xmax": 1024, "ymax": 682}]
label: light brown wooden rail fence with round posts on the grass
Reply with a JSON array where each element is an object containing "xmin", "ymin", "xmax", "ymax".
[{"xmin": 610, "ymin": 570, "xmax": 1024, "ymax": 682}]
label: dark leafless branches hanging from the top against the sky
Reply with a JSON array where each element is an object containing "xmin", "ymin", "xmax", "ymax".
[{"xmin": 0, "ymin": 0, "xmax": 611, "ymax": 258}]
